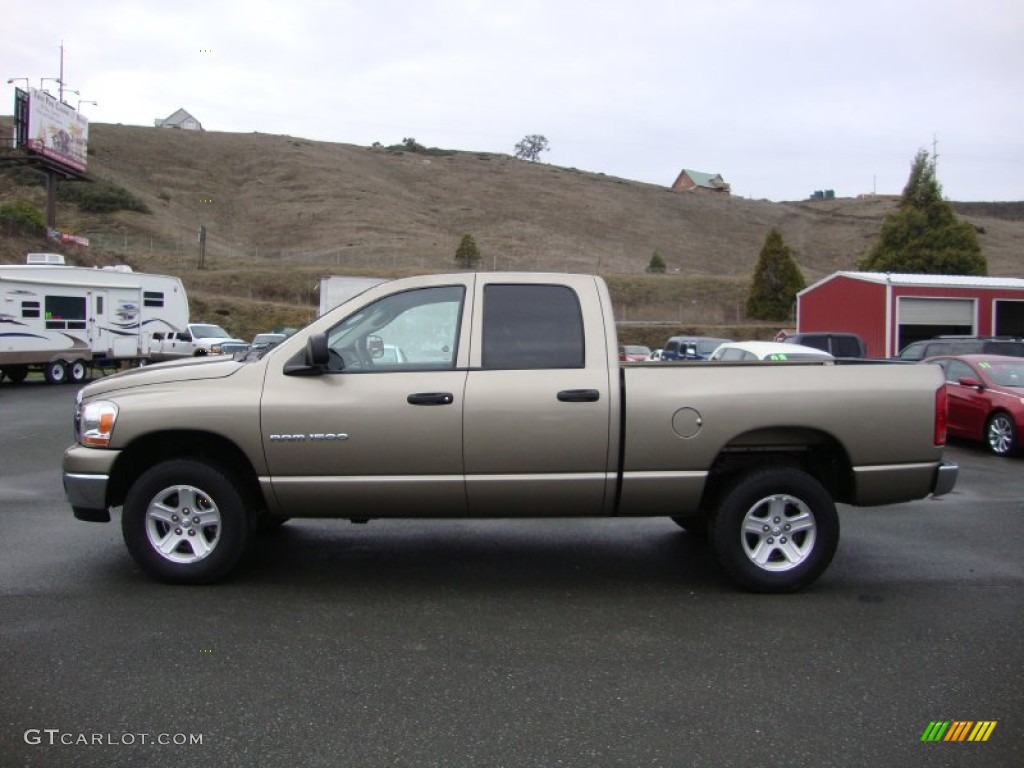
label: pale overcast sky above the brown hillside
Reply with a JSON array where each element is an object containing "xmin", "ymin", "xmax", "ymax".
[{"xmin": 0, "ymin": 0, "xmax": 1024, "ymax": 201}]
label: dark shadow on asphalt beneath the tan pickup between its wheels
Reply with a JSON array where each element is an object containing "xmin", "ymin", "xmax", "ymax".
[{"xmin": 231, "ymin": 519, "xmax": 733, "ymax": 593}]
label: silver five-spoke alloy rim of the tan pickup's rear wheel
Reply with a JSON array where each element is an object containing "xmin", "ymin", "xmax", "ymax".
[{"xmin": 740, "ymin": 494, "xmax": 817, "ymax": 571}]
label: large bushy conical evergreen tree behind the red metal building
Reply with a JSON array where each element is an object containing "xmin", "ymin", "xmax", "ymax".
[{"xmin": 857, "ymin": 150, "xmax": 988, "ymax": 274}]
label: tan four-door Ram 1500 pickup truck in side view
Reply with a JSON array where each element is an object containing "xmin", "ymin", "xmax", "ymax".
[{"xmin": 63, "ymin": 272, "xmax": 957, "ymax": 592}]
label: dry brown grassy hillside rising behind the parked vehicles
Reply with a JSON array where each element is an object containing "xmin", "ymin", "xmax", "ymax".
[{"xmin": 0, "ymin": 120, "xmax": 1024, "ymax": 343}]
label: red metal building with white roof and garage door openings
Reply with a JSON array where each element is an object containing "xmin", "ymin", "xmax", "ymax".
[{"xmin": 797, "ymin": 272, "xmax": 1024, "ymax": 357}]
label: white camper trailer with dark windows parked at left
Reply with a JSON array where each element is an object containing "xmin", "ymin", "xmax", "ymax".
[{"xmin": 0, "ymin": 260, "xmax": 188, "ymax": 384}]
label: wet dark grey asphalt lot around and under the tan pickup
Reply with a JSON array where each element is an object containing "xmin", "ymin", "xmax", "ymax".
[{"xmin": 0, "ymin": 383, "xmax": 1024, "ymax": 767}]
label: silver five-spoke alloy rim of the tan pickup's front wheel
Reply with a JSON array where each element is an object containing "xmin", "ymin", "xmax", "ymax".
[{"xmin": 145, "ymin": 485, "xmax": 221, "ymax": 564}]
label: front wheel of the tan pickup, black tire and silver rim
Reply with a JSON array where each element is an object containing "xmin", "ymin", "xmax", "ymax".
[{"xmin": 121, "ymin": 459, "xmax": 251, "ymax": 584}]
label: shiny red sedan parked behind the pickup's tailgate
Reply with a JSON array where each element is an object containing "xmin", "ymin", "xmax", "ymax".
[{"xmin": 923, "ymin": 354, "xmax": 1024, "ymax": 456}]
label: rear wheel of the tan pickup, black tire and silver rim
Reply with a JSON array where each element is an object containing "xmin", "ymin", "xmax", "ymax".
[{"xmin": 710, "ymin": 468, "xmax": 839, "ymax": 593}]
